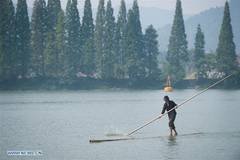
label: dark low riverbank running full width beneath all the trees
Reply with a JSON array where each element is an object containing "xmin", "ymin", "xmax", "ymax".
[{"xmin": 0, "ymin": 78, "xmax": 240, "ymax": 90}]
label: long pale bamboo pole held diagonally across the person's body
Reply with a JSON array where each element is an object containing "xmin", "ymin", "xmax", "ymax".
[{"xmin": 127, "ymin": 74, "xmax": 233, "ymax": 136}]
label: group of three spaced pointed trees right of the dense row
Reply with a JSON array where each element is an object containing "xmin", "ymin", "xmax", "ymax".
[{"xmin": 166, "ymin": 0, "xmax": 239, "ymax": 81}]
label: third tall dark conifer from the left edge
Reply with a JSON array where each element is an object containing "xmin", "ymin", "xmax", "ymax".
[{"xmin": 31, "ymin": 0, "xmax": 47, "ymax": 77}]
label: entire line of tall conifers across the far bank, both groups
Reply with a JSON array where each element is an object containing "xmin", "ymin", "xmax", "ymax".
[{"xmin": 0, "ymin": 0, "xmax": 239, "ymax": 86}]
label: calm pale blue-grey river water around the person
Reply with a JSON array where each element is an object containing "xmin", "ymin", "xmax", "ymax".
[{"xmin": 0, "ymin": 89, "xmax": 240, "ymax": 160}]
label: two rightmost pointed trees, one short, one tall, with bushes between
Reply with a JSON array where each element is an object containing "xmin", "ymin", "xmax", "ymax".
[{"xmin": 194, "ymin": 2, "xmax": 239, "ymax": 78}]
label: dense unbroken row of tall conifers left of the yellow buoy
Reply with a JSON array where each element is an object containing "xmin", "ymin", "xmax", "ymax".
[{"xmin": 0, "ymin": 0, "xmax": 160, "ymax": 82}]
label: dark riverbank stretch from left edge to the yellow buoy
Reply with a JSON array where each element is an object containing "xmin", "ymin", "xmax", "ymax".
[{"xmin": 0, "ymin": 78, "xmax": 164, "ymax": 90}]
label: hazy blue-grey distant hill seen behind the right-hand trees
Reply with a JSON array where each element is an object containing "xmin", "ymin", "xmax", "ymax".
[{"xmin": 158, "ymin": 0, "xmax": 240, "ymax": 53}]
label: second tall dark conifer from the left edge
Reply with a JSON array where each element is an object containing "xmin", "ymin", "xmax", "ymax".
[{"xmin": 14, "ymin": 0, "xmax": 31, "ymax": 77}]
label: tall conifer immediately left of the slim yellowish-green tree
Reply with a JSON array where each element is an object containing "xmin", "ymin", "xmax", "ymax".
[{"xmin": 44, "ymin": 0, "xmax": 61, "ymax": 78}]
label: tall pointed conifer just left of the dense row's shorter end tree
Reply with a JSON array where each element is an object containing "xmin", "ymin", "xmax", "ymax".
[{"xmin": 127, "ymin": 0, "xmax": 146, "ymax": 80}]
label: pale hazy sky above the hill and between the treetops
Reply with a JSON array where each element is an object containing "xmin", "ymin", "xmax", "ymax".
[{"xmin": 21, "ymin": 0, "xmax": 226, "ymax": 14}]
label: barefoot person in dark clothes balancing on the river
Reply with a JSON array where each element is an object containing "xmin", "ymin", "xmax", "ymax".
[{"xmin": 162, "ymin": 96, "xmax": 177, "ymax": 136}]
